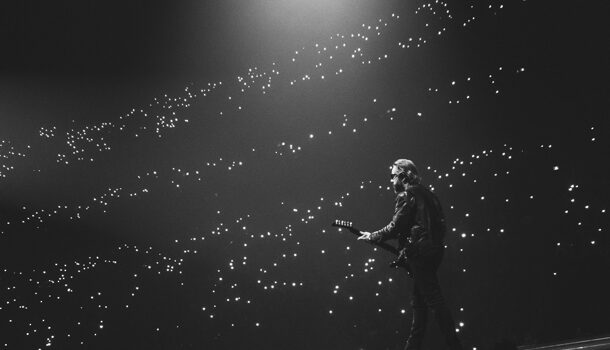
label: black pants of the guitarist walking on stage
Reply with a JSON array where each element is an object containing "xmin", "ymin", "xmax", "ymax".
[{"xmin": 405, "ymin": 246, "xmax": 462, "ymax": 350}]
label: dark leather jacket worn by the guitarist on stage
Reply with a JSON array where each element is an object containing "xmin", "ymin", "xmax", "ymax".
[{"xmin": 371, "ymin": 184, "xmax": 447, "ymax": 248}]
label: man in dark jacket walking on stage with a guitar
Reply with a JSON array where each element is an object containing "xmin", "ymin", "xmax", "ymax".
[{"xmin": 358, "ymin": 159, "xmax": 462, "ymax": 350}]
